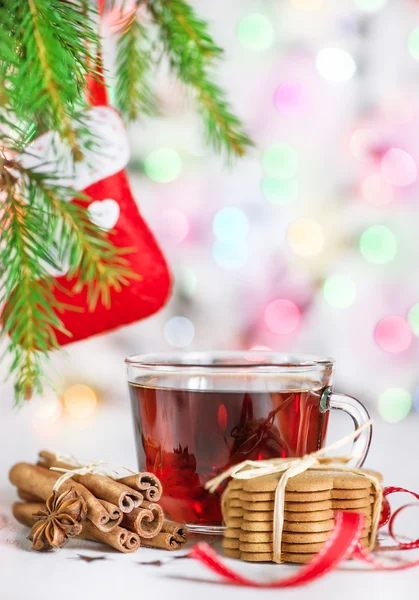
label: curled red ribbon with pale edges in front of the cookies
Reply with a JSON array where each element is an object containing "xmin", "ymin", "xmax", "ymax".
[{"xmin": 189, "ymin": 487, "xmax": 419, "ymax": 589}]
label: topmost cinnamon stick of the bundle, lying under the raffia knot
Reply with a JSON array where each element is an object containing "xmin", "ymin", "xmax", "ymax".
[{"xmin": 39, "ymin": 450, "xmax": 143, "ymax": 513}]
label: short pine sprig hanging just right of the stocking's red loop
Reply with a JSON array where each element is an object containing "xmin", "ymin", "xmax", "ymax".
[{"xmin": 115, "ymin": 12, "xmax": 156, "ymax": 121}]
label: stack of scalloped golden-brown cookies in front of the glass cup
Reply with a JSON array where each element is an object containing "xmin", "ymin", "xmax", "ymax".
[{"xmin": 222, "ymin": 470, "xmax": 381, "ymax": 563}]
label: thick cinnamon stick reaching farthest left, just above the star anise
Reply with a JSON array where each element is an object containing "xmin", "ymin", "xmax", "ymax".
[{"xmin": 9, "ymin": 463, "xmax": 118, "ymax": 532}]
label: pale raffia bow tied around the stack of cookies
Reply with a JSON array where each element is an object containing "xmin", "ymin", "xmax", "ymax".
[{"xmin": 205, "ymin": 421, "xmax": 383, "ymax": 563}]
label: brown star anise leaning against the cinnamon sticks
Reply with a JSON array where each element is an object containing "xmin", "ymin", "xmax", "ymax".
[{"xmin": 29, "ymin": 488, "xmax": 87, "ymax": 551}]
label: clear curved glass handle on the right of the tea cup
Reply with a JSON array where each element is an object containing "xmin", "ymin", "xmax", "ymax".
[{"xmin": 320, "ymin": 388, "xmax": 372, "ymax": 467}]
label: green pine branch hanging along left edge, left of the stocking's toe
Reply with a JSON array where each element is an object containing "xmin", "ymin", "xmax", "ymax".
[{"xmin": 0, "ymin": 171, "xmax": 70, "ymax": 403}]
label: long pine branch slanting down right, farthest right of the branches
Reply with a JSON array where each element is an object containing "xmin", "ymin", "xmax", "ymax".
[{"xmin": 148, "ymin": 0, "xmax": 252, "ymax": 156}]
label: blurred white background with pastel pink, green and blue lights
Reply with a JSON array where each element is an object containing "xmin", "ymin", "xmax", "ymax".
[{"xmin": 4, "ymin": 0, "xmax": 419, "ymax": 432}]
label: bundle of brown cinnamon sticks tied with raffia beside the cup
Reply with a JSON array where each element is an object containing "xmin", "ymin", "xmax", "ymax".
[{"xmin": 9, "ymin": 451, "xmax": 186, "ymax": 552}]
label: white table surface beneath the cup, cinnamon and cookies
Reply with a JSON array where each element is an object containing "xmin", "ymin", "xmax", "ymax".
[{"xmin": 0, "ymin": 394, "xmax": 419, "ymax": 600}]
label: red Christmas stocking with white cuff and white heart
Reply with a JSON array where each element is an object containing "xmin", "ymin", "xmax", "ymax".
[{"xmin": 15, "ymin": 102, "xmax": 171, "ymax": 344}]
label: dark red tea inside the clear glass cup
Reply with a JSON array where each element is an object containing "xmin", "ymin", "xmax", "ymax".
[{"xmin": 130, "ymin": 380, "xmax": 328, "ymax": 526}]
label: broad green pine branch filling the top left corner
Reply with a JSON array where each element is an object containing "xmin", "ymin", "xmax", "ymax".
[{"xmin": 1, "ymin": 0, "xmax": 98, "ymax": 152}]
